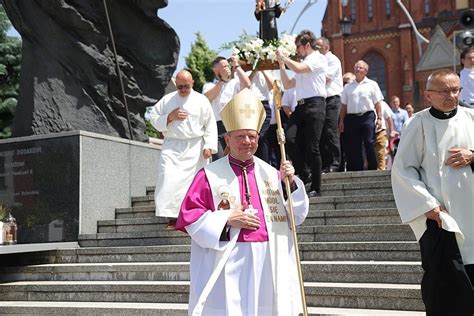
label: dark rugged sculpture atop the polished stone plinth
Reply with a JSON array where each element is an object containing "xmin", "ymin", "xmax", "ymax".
[{"xmin": 3, "ymin": 0, "xmax": 179, "ymax": 141}]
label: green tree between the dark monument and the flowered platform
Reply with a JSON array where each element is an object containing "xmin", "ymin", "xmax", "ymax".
[{"xmin": 186, "ymin": 32, "xmax": 217, "ymax": 92}]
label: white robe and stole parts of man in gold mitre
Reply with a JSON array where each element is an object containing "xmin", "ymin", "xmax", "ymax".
[{"xmin": 186, "ymin": 157, "xmax": 309, "ymax": 316}]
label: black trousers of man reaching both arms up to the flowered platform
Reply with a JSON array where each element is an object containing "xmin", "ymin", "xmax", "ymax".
[{"xmin": 286, "ymin": 97, "xmax": 326, "ymax": 192}]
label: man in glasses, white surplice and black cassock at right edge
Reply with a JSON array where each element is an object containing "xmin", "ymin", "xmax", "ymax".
[{"xmin": 391, "ymin": 70, "xmax": 474, "ymax": 315}]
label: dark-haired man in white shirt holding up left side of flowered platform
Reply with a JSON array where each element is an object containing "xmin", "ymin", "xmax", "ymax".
[{"xmin": 202, "ymin": 56, "xmax": 250, "ymax": 160}]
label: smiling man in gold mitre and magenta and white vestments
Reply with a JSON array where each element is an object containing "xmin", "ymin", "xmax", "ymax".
[{"xmin": 176, "ymin": 89, "xmax": 309, "ymax": 316}]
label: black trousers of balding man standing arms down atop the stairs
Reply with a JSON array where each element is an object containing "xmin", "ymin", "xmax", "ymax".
[{"xmin": 344, "ymin": 111, "xmax": 377, "ymax": 171}]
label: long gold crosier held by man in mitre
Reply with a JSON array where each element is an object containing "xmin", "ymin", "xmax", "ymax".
[{"xmin": 273, "ymin": 80, "xmax": 308, "ymax": 316}]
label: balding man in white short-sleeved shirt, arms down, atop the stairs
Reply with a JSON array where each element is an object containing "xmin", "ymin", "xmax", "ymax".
[{"xmin": 339, "ymin": 60, "xmax": 383, "ymax": 171}]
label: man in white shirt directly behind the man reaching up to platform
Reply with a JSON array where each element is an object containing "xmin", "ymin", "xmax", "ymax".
[{"xmin": 316, "ymin": 37, "xmax": 342, "ymax": 172}]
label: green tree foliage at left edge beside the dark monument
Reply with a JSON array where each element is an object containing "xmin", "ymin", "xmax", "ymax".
[{"xmin": 0, "ymin": 2, "xmax": 21, "ymax": 138}]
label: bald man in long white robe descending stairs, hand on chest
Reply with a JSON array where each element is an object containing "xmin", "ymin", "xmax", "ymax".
[{"xmin": 150, "ymin": 70, "xmax": 217, "ymax": 229}]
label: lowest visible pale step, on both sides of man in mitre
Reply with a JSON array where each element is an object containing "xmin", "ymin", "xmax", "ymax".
[{"xmin": 0, "ymin": 301, "xmax": 425, "ymax": 316}]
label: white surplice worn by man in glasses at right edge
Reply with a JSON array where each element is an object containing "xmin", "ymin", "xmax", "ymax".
[{"xmin": 392, "ymin": 107, "xmax": 474, "ymax": 264}]
